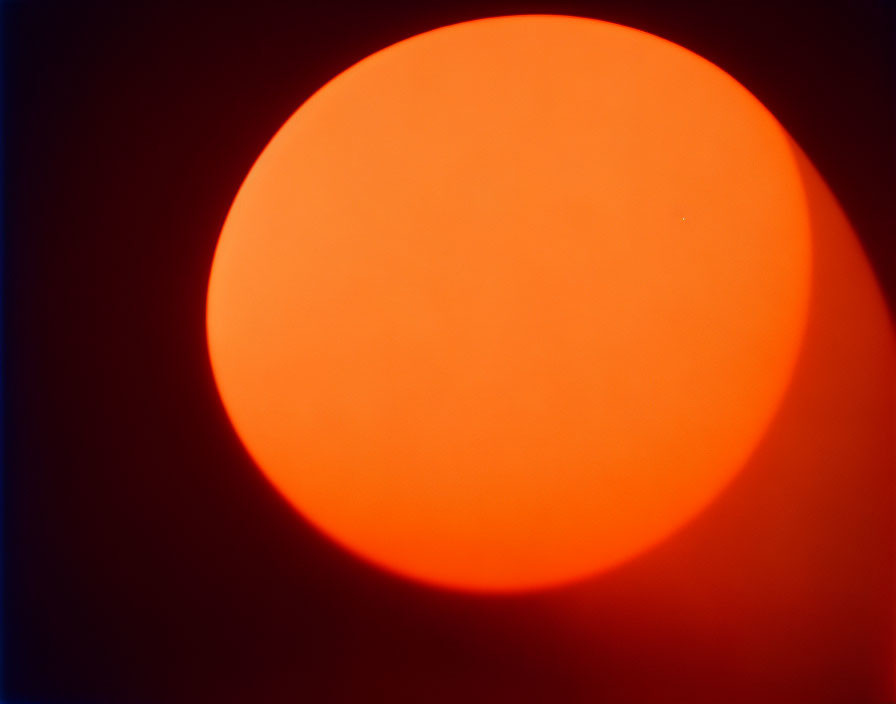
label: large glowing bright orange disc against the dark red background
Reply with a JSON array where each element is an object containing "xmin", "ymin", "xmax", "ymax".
[{"xmin": 207, "ymin": 16, "xmax": 811, "ymax": 591}]
